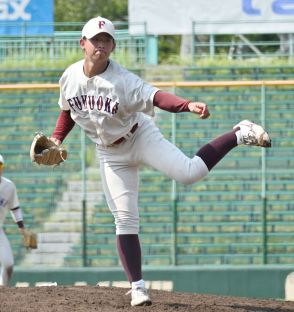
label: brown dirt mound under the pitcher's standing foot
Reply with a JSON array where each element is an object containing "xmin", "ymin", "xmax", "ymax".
[{"xmin": 0, "ymin": 286, "xmax": 294, "ymax": 312}]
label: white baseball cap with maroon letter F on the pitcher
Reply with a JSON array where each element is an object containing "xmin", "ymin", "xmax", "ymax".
[{"xmin": 82, "ymin": 16, "xmax": 114, "ymax": 39}]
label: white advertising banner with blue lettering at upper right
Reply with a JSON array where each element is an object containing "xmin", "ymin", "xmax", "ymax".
[{"xmin": 129, "ymin": 0, "xmax": 294, "ymax": 35}]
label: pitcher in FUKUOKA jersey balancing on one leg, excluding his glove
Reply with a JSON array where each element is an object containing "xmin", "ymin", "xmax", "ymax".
[{"xmin": 47, "ymin": 17, "xmax": 271, "ymax": 306}]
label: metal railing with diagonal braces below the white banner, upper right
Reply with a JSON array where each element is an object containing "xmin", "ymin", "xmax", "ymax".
[{"xmin": 192, "ymin": 20, "xmax": 294, "ymax": 63}]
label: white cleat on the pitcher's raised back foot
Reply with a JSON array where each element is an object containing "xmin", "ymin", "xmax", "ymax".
[{"xmin": 233, "ymin": 120, "xmax": 271, "ymax": 147}]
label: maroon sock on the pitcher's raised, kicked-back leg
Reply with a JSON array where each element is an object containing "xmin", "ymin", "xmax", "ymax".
[{"xmin": 196, "ymin": 129, "xmax": 239, "ymax": 170}]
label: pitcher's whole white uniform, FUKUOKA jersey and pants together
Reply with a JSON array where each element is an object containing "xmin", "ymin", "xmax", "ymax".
[{"xmin": 55, "ymin": 60, "xmax": 208, "ymax": 235}]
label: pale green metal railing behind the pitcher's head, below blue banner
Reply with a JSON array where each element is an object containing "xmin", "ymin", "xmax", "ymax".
[{"xmin": 0, "ymin": 22, "xmax": 148, "ymax": 66}]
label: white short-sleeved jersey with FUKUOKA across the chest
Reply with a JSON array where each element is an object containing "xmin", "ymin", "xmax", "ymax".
[{"xmin": 59, "ymin": 60, "xmax": 158, "ymax": 146}]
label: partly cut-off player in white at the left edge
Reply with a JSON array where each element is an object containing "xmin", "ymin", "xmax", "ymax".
[{"xmin": 0, "ymin": 155, "xmax": 36, "ymax": 286}]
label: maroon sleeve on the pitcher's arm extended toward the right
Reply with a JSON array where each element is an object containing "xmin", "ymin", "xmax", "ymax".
[{"xmin": 153, "ymin": 91, "xmax": 191, "ymax": 113}]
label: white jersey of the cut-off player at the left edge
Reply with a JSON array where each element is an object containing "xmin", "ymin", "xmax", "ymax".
[{"xmin": 0, "ymin": 176, "xmax": 19, "ymax": 227}]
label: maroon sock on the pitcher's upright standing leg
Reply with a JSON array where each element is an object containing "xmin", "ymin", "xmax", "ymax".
[{"xmin": 116, "ymin": 234, "xmax": 142, "ymax": 282}]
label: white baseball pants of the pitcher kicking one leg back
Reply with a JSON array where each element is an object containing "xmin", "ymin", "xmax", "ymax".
[{"xmin": 97, "ymin": 118, "xmax": 209, "ymax": 235}]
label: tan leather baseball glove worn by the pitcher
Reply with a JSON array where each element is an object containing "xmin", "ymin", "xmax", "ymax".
[{"xmin": 30, "ymin": 132, "xmax": 67, "ymax": 166}]
